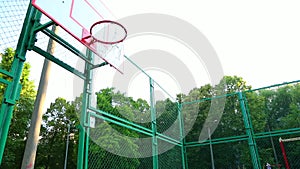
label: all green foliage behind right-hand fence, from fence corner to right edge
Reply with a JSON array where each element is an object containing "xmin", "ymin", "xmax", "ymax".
[{"xmin": 184, "ymin": 76, "xmax": 300, "ymax": 168}]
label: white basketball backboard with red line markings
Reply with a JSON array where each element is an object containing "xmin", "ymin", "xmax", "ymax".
[{"xmin": 32, "ymin": 0, "xmax": 123, "ymax": 73}]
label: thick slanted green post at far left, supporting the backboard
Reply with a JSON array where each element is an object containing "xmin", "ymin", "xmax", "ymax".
[{"xmin": 0, "ymin": 5, "xmax": 37, "ymax": 164}]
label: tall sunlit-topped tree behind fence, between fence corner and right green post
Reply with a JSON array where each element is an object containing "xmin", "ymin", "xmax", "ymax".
[{"xmin": 183, "ymin": 76, "xmax": 261, "ymax": 168}]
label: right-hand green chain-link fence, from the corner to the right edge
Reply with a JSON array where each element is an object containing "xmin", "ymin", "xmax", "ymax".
[{"xmin": 182, "ymin": 81, "xmax": 300, "ymax": 168}]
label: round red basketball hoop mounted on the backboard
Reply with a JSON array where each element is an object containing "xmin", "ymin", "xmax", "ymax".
[{"xmin": 84, "ymin": 20, "xmax": 127, "ymax": 45}]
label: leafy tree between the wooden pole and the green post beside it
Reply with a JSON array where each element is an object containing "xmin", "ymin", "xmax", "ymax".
[{"xmin": 36, "ymin": 98, "xmax": 79, "ymax": 169}]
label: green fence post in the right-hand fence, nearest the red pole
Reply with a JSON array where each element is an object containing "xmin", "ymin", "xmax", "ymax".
[{"xmin": 238, "ymin": 92, "xmax": 261, "ymax": 169}]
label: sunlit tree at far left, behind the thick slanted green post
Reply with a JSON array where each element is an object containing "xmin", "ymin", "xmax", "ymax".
[{"xmin": 0, "ymin": 48, "xmax": 36, "ymax": 168}]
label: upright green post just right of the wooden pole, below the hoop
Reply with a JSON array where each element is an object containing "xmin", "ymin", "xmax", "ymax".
[{"xmin": 77, "ymin": 50, "xmax": 93, "ymax": 169}]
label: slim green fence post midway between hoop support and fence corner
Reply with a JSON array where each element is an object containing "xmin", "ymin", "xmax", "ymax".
[{"xmin": 149, "ymin": 78, "xmax": 158, "ymax": 169}]
